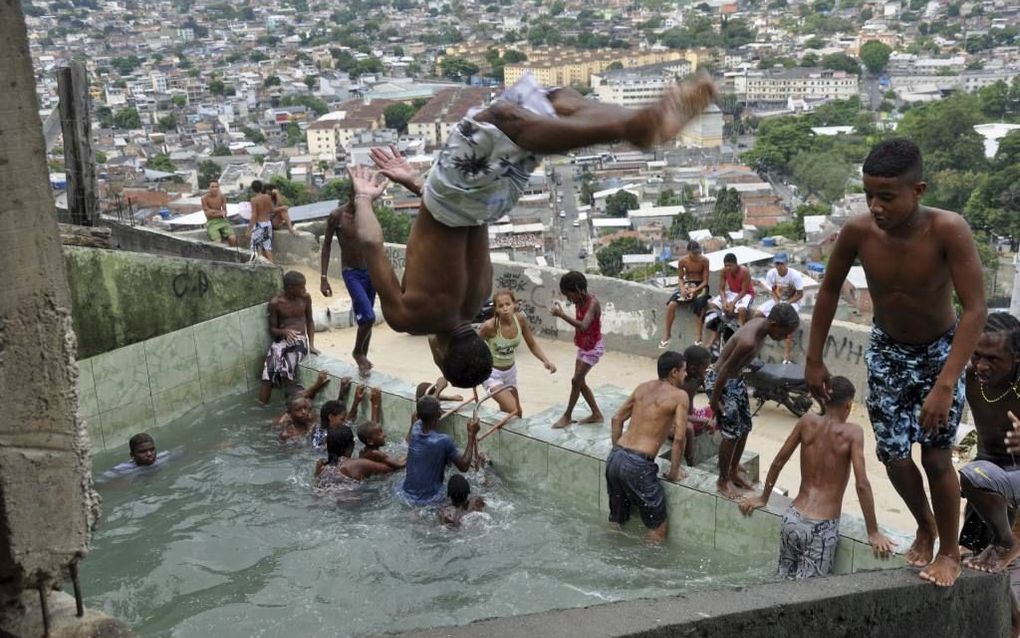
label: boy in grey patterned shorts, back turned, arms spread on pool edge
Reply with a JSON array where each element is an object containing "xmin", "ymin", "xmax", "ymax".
[{"xmin": 740, "ymin": 377, "xmax": 895, "ymax": 580}]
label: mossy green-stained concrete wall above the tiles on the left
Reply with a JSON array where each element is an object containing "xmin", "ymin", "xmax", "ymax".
[{"xmin": 64, "ymin": 247, "xmax": 283, "ymax": 359}]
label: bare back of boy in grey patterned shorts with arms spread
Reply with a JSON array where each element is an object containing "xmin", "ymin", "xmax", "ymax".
[{"xmin": 794, "ymin": 413, "xmax": 864, "ymax": 521}]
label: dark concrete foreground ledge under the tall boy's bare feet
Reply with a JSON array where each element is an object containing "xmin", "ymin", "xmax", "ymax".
[{"xmin": 386, "ymin": 569, "xmax": 1010, "ymax": 638}]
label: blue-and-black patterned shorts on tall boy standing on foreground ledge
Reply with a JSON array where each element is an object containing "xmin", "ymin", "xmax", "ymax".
[{"xmin": 864, "ymin": 326, "xmax": 964, "ymax": 464}]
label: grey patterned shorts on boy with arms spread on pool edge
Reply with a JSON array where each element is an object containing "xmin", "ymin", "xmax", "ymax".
[{"xmin": 776, "ymin": 505, "xmax": 839, "ymax": 581}]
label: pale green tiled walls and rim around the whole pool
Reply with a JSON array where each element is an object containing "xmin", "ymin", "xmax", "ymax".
[{"xmin": 79, "ymin": 304, "xmax": 908, "ymax": 574}]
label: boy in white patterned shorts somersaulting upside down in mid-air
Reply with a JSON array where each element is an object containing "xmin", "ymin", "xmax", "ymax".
[{"xmin": 344, "ymin": 71, "xmax": 715, "ymax": 388}]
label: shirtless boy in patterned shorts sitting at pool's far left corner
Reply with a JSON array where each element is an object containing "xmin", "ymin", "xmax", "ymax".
[{"xmin": 258, "ymin": 271, "xmax": 318, "ymax": 404}]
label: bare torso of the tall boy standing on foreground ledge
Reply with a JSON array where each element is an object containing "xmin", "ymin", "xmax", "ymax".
[{"xmin": 842, "ymin": 207, "xmax": 980, "ymax": 344}]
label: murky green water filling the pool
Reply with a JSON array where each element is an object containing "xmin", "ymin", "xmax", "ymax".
[{"xmin": 82, "ymin": 389, "xmax": 771, "ymax": 638}]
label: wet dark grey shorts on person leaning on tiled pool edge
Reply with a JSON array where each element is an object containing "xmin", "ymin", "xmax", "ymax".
[{"xmin": 606, "ymin": 446, "xmax": 666, "ymax": 530}]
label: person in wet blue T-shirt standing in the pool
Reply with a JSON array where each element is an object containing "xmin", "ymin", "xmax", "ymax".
[{"xmin": 399, "ymin": 396, "xmax": 480, "ymax": 505}]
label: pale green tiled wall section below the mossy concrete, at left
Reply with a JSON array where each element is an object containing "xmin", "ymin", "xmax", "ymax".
[{"xmin": 79, "ymin": 303, "xmax": 270, "ymax": 457}]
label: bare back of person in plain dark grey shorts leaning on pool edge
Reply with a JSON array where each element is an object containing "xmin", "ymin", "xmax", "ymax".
[{"xmin": 616, "ymin": 380, "xmax": 690, "ymax": 456}]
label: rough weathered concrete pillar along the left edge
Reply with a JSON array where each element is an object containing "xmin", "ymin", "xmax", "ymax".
[{"xmin": 0, "ymin": 0, "xmax": 99, "ymax": 616}]
